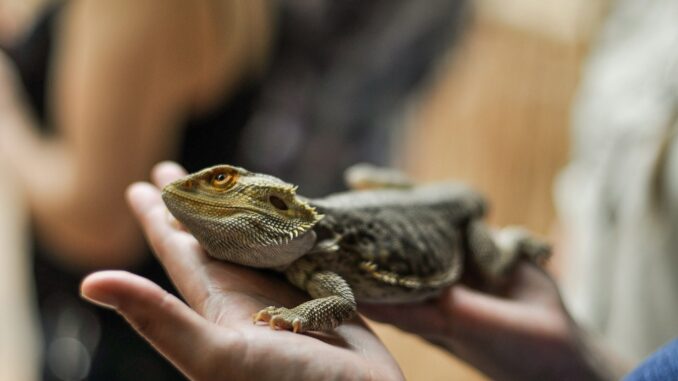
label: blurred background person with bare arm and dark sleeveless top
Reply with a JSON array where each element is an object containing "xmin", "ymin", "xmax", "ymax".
[{"xmin": 0, "ymin": 0, "xmax": 466, "ymax": 380}]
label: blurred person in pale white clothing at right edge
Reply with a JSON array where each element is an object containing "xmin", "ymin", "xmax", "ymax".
[{"xmin": 556, "ymin": 0, "xmax": 678, "ymax": 362}]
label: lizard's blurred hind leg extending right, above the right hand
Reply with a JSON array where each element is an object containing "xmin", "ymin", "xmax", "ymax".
[{"xmin": 468, "ymin": 221, "xmax": 551, "ymax": 279}]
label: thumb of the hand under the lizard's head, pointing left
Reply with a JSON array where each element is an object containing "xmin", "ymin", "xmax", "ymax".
[{"xmin": 81, "ymin": 271, "xmax": 222, "ymax": 377}]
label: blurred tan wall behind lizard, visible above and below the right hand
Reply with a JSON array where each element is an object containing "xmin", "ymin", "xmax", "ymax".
[{"xmin": 375, "ymin": 5, "xmax": 600, "ymax": 380}]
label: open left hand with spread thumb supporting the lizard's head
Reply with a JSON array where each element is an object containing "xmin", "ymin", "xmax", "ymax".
[{"xmin": 82, "ymin": 163, "xmax": 403, "ymax": 381}]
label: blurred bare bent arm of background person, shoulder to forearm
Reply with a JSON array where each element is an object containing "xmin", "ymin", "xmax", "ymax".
[{"xmin": 0, "ymin": 0, "xmax": 270, "ymax": 267}]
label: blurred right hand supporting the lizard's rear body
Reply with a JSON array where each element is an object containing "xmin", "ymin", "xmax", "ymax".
[{"xmin": 359, "ymin": 262, "xmax": 624, "ymax": 380}]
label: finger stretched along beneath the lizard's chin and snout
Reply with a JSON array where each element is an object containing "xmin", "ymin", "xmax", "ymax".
[{"xmin": 127, "ymin": 183, "xmax": 209, "ymax": 306}]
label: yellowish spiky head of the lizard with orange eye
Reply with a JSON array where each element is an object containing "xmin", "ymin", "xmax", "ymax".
[{"xmin": 162, "ymin": 165, "xmax": 322, "ymax": 268}]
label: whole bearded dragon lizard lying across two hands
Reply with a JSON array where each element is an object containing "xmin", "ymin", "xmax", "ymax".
[{"xmin": 162, "ymin": 164, "xmax": 550, "ymax": 333}]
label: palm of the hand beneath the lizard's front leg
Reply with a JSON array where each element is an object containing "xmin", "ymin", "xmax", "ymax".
[{"xmin": 189, "ymin": 252, "xmax": 399, "ymax": 380}]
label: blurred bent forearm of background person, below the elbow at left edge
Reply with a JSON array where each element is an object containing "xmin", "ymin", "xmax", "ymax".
[{"xmin": 0, "ymin": 113, "xmax": 149, "ymax": 267}]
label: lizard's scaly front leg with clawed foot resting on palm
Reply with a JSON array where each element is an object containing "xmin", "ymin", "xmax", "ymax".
[{"xmin": 254, "ymin": 266, "xmax": 356, "ymax": 332}]
